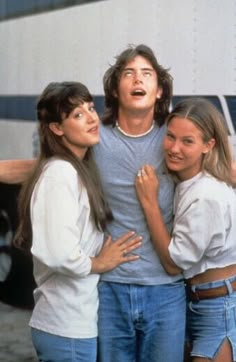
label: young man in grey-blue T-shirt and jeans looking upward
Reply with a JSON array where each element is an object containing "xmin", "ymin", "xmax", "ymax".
[{"xmin": 94, "ymin": 45, "xmax": 185, "ymax": 362}]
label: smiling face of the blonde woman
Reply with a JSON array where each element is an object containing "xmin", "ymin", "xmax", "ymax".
[{"xmin": 163, "ymin": 117, "xmax": 214, "ymax": 181}]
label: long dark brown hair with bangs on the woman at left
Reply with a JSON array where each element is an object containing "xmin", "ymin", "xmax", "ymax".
[{"xmin": 14, "ymin": 82, "xmax": 112, "ymax": 251}]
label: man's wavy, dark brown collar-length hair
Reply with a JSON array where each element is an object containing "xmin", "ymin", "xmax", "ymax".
[{"xmin": 102, "ymin": 44, "xmax": 173, "ymax": 126}]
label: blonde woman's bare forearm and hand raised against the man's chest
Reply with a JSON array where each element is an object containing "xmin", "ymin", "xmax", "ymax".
[{"xmin": 135, "ymin": 165, "xmax": 181, "ymax": 275}]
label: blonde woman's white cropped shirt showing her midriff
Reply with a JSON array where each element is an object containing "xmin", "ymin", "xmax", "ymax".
[{"xmin": 169, "ymin": 172, "xmax": 236, "ymax": 279}]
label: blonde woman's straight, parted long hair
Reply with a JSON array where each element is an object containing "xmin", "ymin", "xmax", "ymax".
[{"xmin": 166, "ymin": 97, "xmax": 232, "ymax": 185}]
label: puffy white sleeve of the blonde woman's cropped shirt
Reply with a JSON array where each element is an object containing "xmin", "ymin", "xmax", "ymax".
[{"xmin": 169, "ymin": 199, "xmax": 226, "ymax": 271}]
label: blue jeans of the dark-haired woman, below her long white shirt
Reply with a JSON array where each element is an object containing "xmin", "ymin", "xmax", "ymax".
[{"xmin": 31, "ymin": 328, "xmax": 97, "ymax": 362}]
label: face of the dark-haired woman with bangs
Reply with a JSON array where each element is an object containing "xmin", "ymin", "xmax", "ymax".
[{"xmin": 50, "ymin": 102, "xmax": 99, "ymax": 159}]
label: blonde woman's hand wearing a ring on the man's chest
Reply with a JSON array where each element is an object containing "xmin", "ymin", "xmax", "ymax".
[{"xmin": 135, "ymin": 165, "xmax": 159, "ymax": 208}]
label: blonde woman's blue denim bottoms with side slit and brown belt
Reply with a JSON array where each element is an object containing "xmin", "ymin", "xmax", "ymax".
[{"xmin": 187, "ymin": 276, "xmax": 236, "ymax": 361}]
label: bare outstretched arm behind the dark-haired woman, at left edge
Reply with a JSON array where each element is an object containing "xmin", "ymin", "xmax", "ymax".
[{"xmin": 0, "ymin": 160, "xmax": 35, "ymax": 184}]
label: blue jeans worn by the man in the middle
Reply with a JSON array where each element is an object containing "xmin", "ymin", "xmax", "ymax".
[{"xmin": 98, "ymin": 281, "xmax": 186, "ymax": 362}]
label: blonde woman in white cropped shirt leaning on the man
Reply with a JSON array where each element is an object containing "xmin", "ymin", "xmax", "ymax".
[{"xmin": 136, "ymin": 98, "xmax": 236, "ymax": 362}]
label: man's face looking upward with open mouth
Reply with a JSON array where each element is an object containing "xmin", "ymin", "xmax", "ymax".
[{"xmin": 117, "ymin": 55, "xmax": 162, "ymax": 113}]
